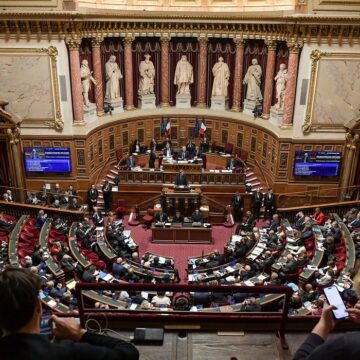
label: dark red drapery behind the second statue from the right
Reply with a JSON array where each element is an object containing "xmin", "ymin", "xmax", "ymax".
[{"xmin": 241, "ymin": 40, "xmax": 267, "ymax": 104}]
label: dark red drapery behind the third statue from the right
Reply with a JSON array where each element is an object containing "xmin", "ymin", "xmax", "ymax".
[{"xmin": 206, "ymin": 39, "xmax": 235, "ymax": 108}]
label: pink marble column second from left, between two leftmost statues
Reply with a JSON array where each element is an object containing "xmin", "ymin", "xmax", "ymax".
[{"xmin": 91, "ymin": 37, "xmax": 105, "ymax": 116}]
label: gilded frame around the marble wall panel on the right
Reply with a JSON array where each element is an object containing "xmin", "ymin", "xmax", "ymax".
[{"xmin": 302, "ymin": 49, "xmax": 360, "ymax": 134}]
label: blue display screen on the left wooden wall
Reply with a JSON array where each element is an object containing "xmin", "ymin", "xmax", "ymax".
[{"xmin": 24, "ymin": 147, "xmax": 71, "ymax": 173}]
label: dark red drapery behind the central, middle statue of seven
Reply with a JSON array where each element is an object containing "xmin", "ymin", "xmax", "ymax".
[{"xmin": 169, "ymin": 38, "xmax": 199, "ymax": 105}]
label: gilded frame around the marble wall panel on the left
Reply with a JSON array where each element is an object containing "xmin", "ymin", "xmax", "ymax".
[{"xmin": 0, "ymin": 46, "xmax": 64, "ymax": 131}]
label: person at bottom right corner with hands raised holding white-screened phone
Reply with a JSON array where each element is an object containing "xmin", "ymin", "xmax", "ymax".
[{"xmin": 293, "ymin": 300, "xmax": 360, "ymax": 360}]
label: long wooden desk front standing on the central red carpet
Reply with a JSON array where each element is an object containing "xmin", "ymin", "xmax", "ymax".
[{"xmin": 151, "ymin": 225, "xmax": 212, "ymax": 244}]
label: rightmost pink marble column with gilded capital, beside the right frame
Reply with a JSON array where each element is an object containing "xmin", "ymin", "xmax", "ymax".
[{"xmin": 281, "ymin": 40, "xmax": 303, "ymax": 128}]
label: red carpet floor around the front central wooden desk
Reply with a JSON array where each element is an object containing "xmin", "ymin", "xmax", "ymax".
[{"xmin": 124, "ymin": 216, "xmax": 236, "ymax": 282}]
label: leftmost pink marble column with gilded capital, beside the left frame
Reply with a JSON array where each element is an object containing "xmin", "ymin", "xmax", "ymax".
[{"xmin": 66, "ymin": 39, "xmax": 84, "ymax": 125}]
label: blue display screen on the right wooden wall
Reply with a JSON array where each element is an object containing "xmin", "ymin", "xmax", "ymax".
[{"xmin": 294, "ymin": 151, "xmax": 341, "ymax": 177}]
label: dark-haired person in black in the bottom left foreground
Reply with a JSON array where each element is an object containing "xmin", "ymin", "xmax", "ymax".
[{"xmin": 0, "ymin": 268, "xmax": 139, "ymax": 360}]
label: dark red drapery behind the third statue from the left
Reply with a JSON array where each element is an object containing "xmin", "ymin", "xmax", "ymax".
[{"xmin": 132, "ymin": 38, "xmax": 161, "ymax": 107}]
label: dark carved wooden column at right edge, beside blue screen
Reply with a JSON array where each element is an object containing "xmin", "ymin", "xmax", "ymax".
[{"xmin": 340, "ymin": 133, "xmax": 360, "ymax": 200}]
